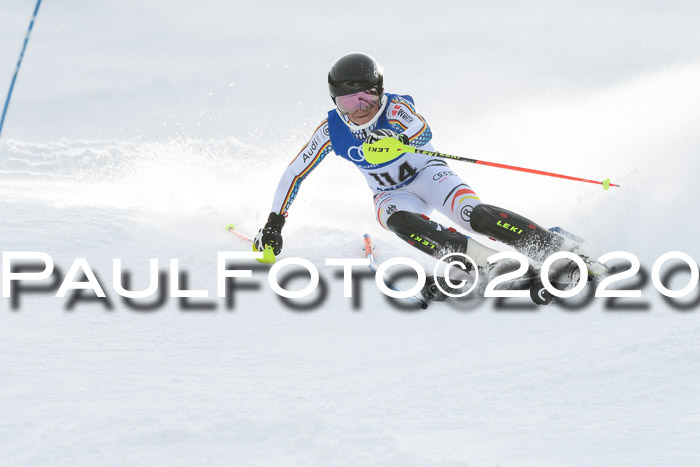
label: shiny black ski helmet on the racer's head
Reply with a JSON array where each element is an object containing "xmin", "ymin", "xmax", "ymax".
[{"xmin": 328, "ymin": 53, "xmax": 384, "ymax": 102}]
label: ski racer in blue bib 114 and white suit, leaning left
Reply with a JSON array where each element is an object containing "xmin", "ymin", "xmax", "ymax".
[{"xmin": 253, "ymin": 53, "xmax": 592, "ymax": 298}]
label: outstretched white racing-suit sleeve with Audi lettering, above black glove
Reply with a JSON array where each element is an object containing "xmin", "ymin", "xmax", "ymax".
[{"xmin": 271, "ymin": 120, "xmax": 332, "ymax": 215}]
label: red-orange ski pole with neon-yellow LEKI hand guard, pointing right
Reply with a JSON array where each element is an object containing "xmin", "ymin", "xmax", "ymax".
[{"xmin": 362, "ymin": 138, "xmax": 620, "ymax": 190}]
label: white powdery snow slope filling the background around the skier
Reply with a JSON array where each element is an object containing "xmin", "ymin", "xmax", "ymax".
[{"xmin": 0, "ymin": 0, "xmax": 700, "ymax": 466}]
